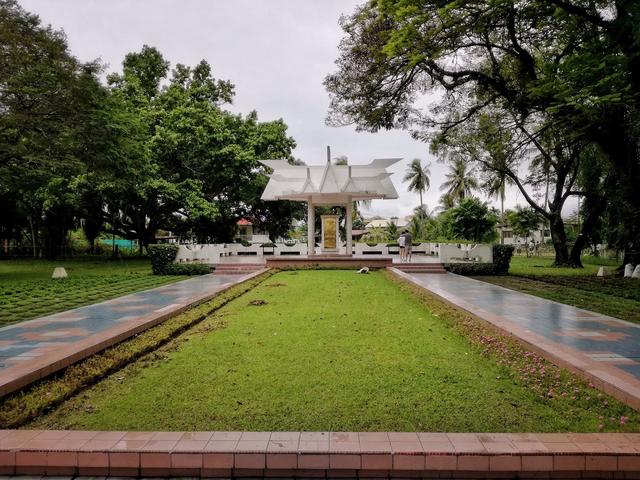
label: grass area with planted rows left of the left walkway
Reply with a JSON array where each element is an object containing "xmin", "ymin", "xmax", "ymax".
[{"xmin": 0, "ymin": 259, "xmax": 184, "ymax": 326}]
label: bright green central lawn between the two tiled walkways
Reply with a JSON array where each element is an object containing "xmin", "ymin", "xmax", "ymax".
[{"xmin": 29, "ymin": 271, "xmax": 638, "ymax": 432}]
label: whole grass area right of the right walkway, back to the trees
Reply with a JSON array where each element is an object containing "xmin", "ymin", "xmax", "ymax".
[{"xmin": 477, "ymin": 256, "xmax": 640, "ymax": 323}]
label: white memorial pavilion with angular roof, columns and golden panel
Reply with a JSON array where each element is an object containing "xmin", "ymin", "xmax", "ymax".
[{"xmin": 261, "ymin": 147, "xmax": 401, "ymax": 256}]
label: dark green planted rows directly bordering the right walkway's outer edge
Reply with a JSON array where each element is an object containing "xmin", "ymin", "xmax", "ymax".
[{"xmin": 476, "ymin": 275, "xmax": 640, "ymax": 323}]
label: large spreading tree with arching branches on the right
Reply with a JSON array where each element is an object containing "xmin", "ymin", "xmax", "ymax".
[{"xmin": 325, "ymin": 0, "xmax": 640, "ymax": 264}]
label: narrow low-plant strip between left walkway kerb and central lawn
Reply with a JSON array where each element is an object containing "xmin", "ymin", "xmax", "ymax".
[{"xmin": 0, "ymin": 272, "xmax": 271, "ymax": 428}]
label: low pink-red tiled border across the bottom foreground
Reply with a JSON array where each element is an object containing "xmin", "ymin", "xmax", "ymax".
[{"xmin": 0, "ymin": 430, "xmax": 640, "ymax": 479}]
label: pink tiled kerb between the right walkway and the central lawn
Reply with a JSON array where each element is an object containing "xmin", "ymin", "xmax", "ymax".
[{"xmin": 388, "ymin": 268, "xmax": 640, "ymax": 410}]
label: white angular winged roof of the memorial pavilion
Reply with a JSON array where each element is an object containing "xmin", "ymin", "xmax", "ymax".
[{"xmin": 261, "ymin": 158, "xmax": 402, "ymax": 205}]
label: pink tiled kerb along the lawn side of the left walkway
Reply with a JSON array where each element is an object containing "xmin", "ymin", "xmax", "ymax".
[{"xmin": 0, "ymin": 268, "xmax": 268, "ymax": 397}]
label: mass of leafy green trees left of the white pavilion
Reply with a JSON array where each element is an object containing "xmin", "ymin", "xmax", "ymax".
[{"xmin": 0, "ymin": 0, "xmax": 302, "ymax": 258}]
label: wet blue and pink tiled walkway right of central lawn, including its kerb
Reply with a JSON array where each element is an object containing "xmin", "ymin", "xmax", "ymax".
[{"xmin": 395, "ymin": 270, "xmax": 640, "ymax": 409}]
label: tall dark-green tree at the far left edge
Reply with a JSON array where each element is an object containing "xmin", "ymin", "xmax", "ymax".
[{"xmin": 0, "ymin": 0, "xmax": 115, "ymax": 258}]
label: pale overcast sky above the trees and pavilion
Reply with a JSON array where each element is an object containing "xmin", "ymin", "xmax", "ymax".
[{"xmin": 19, "ymin": 0, "xmax": 576, "ymax": 216}]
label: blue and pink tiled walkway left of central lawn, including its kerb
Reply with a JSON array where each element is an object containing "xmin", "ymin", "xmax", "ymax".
[{"xmin": 0, "ymin": 271, "xmax": 262, "ymax": 395}]
